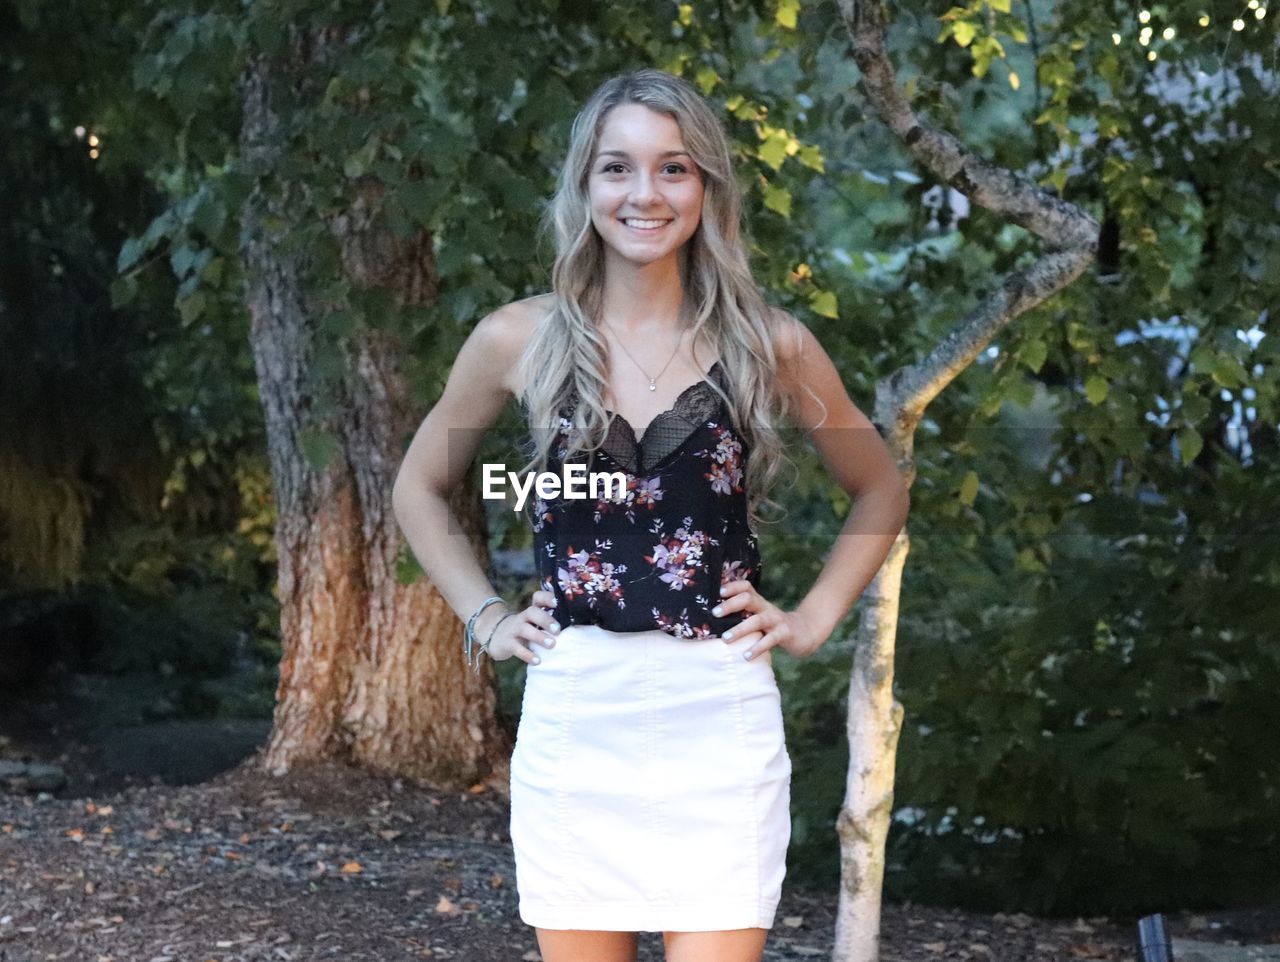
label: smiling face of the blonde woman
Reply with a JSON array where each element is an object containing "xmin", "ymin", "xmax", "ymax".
[{"xmin": 588, "ymin": 104, "xmax": 703, "ymax": 264}]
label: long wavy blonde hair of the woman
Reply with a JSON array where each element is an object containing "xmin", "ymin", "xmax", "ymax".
[{"xmin": 520, "ymin": 69, "xmax": 799, "ymax": 526}]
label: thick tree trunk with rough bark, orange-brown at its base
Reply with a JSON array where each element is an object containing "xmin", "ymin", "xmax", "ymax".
[{"xmin": 242, "ymin": 32, "xmax": 509, "ymax": 789}]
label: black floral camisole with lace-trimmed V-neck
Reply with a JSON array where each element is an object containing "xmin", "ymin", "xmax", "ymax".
[{"xmin": 519, "ymin": 361, "xmax": 762, "ymax": 638}]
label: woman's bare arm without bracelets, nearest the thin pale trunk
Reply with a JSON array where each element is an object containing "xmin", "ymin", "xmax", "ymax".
[{"xmin": 778, "ymin": 315, "xmax": 911, "ymax": 645}]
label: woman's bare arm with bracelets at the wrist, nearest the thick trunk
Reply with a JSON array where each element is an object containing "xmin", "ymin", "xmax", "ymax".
[{"xmin": 392, "ymin": 301, "xmax": 527, "ymax": 647}]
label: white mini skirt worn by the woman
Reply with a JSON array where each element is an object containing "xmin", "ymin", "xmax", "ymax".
[{"xmin": 511, "ymin": 624, "xmax": 791, "ymax": 933}]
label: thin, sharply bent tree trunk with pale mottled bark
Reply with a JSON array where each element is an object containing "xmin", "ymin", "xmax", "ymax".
[{"xmin": 832, "ymin": 0, "xmax": 1098, "ymax": 962}]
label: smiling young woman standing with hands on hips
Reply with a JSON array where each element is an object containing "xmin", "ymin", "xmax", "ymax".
[{"xmin": 394, "ymin": 69, "xmax": 909, "ymax": 962}]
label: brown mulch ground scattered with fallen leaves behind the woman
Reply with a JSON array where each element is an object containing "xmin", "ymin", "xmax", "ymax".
[{"xmin": 0, "ymin": 695, "xmax": 1280, "ymax": 962}]
